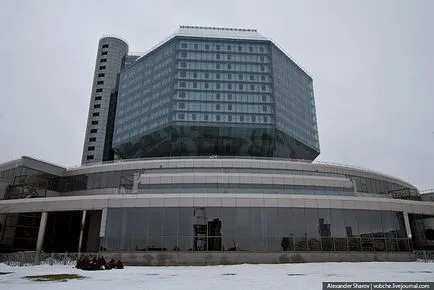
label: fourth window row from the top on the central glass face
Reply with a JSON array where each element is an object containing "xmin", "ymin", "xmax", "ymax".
[{"xmin": 178, "ymin": 71, "xmax": 270, "ymax": 82}]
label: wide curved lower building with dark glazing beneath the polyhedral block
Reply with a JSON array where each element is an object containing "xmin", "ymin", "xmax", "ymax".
[{"xmin": 0, "ymin": 156, "xmax": 434, "ymax": 265}]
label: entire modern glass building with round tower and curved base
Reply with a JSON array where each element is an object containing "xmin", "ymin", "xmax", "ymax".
[{"xmin": 0, "ymin": 26, "xmax": 434, "ymax": 265}]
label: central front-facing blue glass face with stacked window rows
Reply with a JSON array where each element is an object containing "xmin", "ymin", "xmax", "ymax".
[{"xmin": 172, "ymin": 39, "xmax": 274, "ymax": 128}]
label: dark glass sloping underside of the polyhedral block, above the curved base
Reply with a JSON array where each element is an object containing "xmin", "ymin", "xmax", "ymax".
[{"xmin": 114, "ymin": 123, "xmax": 318, "ymax": 160}]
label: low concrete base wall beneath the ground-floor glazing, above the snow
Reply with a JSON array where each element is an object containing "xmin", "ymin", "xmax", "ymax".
[{"xmin": 100, "ymin": 252, "xmax": 416, "ymax": 266}]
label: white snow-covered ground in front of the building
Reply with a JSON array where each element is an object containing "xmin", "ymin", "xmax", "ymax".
[{"xmin": 0, "ymin": 262, "xmax": 434, "ymax": 290}]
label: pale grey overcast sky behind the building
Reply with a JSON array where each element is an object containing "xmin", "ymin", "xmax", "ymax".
[{"xmin": 0, "ymin": 0, "xmax": 434, "ymax": 189}]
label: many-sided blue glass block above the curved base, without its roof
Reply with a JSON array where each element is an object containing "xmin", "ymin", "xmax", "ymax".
[{"xmin": 113, "ymin": 36, "xmax": 319, "ymax": 160}]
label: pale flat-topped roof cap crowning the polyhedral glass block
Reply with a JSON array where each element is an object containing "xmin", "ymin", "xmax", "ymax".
[{"xmin": 174, "ymin": 25, "xmax": 268, "ymax": 40}]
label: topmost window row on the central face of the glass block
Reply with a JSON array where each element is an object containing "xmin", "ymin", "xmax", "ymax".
[{"xmin": 179, "ymin": 42, "xmax": 267, "ymax": 53}]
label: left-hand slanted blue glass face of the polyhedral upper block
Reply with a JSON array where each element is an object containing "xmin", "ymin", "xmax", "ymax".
[{"xmin": 113, "ymin": 42, "xmax": 174, "ymax": 147}]
